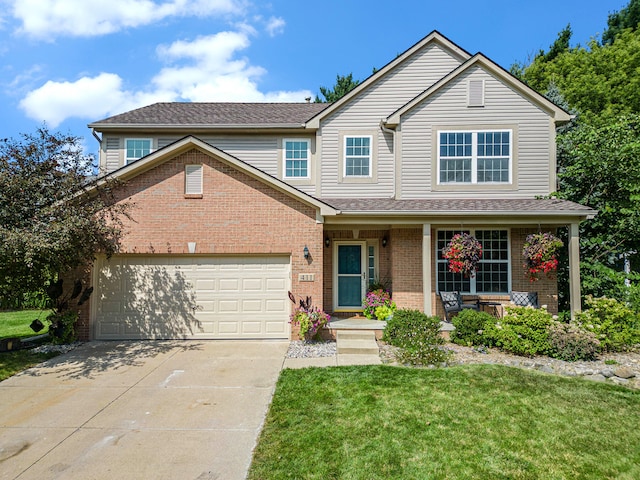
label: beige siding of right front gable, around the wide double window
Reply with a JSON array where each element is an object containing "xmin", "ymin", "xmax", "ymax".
[{"xmin": 401, "ymin": 67, "xmax": 554, "ymax": 199}]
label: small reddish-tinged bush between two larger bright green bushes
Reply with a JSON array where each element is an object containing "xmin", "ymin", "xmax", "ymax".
[{"xmin": 549, "ymin": 322, "xmax": 600, "ymax": 362}]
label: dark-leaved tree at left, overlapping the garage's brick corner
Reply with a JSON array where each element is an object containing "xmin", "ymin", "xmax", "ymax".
[{"xmin": 0, "ymin": 127, "xmax": 129, "ymax": 308}]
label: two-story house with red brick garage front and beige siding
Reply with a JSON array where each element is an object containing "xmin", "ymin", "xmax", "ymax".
[{"xmin": 80, "ymin": 31, "xmax": 595, "ymax": 339}]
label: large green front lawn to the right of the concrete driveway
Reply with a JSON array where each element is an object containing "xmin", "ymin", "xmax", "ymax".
[{"xmin": 249, "ymin": 365, "xmax": 640, "ymax": 480}]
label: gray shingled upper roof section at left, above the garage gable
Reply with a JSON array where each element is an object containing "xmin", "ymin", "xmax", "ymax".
[{"xmin": 89, "ymin": 102, "xmax": 330, "ymax": 127}]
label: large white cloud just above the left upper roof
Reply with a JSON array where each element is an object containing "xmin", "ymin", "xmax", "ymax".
[{"xmin": 20, "ymin": 29, "xmax": 312, "ymax": 128}]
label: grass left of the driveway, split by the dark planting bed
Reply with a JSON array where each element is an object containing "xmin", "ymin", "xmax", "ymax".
[{"xmin": 0, "ymin": 310, "xmax": 59, "ymax": 381}]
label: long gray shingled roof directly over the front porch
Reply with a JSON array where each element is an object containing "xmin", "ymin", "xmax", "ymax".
[{"xmin": 321, "ymin": 198, "xmax": 596, "ymax": 215}]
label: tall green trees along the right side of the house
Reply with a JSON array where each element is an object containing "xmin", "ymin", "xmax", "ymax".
[{"xmin": 512, "ymin": 0, "xmax": 640, "ymax": 310}]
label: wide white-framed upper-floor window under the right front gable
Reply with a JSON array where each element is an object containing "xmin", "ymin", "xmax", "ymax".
[{"xmin": 438, "ymin": 130, "xmax": 513, "ymax": 184}]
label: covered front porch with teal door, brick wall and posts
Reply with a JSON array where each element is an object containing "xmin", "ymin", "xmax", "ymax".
[{"xmin": 323, "ymin": 224, "xmax": 580, "ymax": 322}]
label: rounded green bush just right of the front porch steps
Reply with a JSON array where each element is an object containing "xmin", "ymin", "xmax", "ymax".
[{"xmin": 382, "ymin": 309, "xmax": 451, "ymax": 365}]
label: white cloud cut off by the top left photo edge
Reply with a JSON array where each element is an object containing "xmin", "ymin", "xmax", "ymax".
[{"xmin": 11, "ymin": 0, "xmax": 244, "ymax": 40}]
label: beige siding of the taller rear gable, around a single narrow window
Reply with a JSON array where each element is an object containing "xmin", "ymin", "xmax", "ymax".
[{"xmin": 319, "ymin": 43, "xmax": 461, "ymax": 197}]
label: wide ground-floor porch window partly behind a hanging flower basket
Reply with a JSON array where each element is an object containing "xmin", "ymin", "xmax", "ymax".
[{"xmin": 436, "ymin": 229, "xmax": 510, "ymax": 294}]
